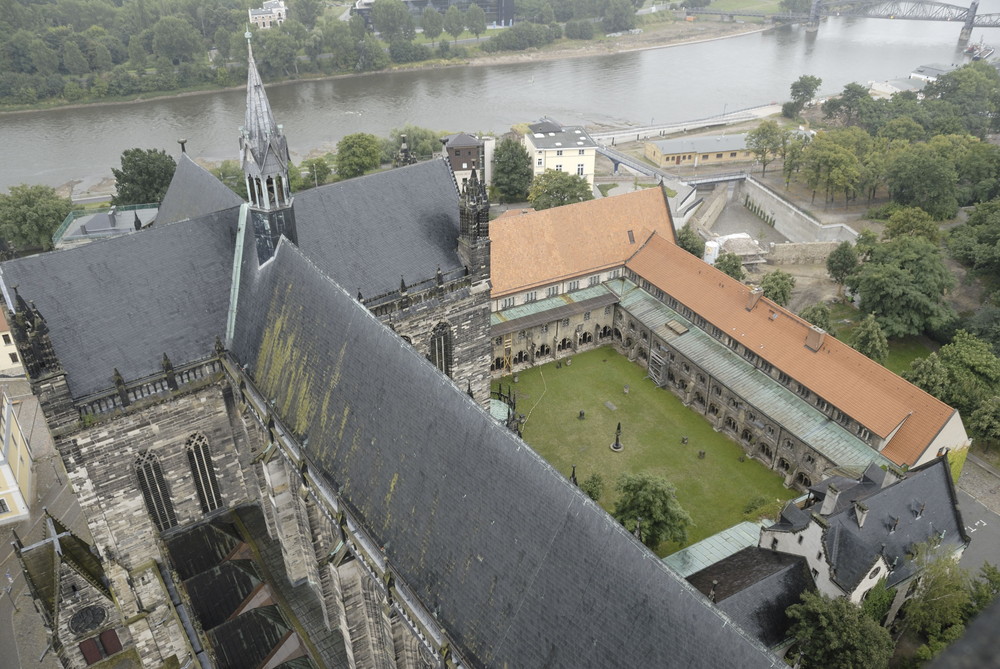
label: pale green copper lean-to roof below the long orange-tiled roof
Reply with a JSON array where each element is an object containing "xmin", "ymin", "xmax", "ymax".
[{"xmin": 615, "ymin": 281, "xmax": 894, "ymax": 471}]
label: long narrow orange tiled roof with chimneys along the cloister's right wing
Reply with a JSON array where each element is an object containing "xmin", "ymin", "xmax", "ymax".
[{"xmin": 627, "ymin": 235, "xmax": 955, "ymax": 465}]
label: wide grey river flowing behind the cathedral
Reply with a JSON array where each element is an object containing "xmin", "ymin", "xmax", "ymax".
[{"xmin": 0, "ymin": 13, "xmax": 1000, "ymax": 191}]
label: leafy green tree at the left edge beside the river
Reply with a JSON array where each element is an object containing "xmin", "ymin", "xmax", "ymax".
[{"xmin": 0, "ymin": 184, "xmax": 73, "ymax": 250}]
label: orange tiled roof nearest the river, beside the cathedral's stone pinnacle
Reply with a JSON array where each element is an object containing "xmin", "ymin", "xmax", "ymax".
[{"xmin": 490, "ymin": 188, "xmax": 674, "ymax": 298}]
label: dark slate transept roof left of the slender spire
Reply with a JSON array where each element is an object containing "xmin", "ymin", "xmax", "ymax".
[{"xmin": 0, "ymin": 209, "xmax": 239, "ymax": 397}]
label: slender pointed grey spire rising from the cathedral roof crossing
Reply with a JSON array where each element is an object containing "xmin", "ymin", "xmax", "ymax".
[{"xmin": 240, "ymin": 32, "xmax": 298, "ymax": 263}]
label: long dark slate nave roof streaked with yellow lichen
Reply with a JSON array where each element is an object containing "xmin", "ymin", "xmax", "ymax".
[{"xmin": 232, "ymin": 241, "xmax": 781, "ymax": 667}]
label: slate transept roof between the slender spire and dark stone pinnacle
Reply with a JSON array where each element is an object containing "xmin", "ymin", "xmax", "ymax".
[{"xmin": 294, "ymin": 160, "xmax": 462, "ymax": 298}]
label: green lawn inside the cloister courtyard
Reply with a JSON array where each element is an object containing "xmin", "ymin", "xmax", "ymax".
[{"xmin": 501, "ymin": 347, "xmax": 795, "ymax": 555}]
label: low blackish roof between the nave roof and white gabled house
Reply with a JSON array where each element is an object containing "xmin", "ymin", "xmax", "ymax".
[{"xmin": 688, "ymin": 546, "xmax": 815, "ymax": 648}]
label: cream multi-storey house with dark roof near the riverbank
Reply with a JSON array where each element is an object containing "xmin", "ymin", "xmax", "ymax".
[{"xmin": 522, "ymin": 118, "xmax": 597, "ymax": 186}]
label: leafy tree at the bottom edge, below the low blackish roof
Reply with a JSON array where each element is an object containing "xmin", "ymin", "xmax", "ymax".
[{"xmin": 785, "ymin": 591, "xmax": 893, "ymax": 669}]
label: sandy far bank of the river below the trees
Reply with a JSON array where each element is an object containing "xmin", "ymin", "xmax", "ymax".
[{"xmin": 0, "ymin": 20, "xmax": 770, "ymax": 116}]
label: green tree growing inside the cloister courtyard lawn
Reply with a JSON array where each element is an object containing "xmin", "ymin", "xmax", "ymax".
[{"xmin": 612, "ymin": 474, "xmax": 691, "ymax": 548}]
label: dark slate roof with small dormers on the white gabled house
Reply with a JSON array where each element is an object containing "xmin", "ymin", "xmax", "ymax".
[{"xmin": 770, "ymin": 456, "xmax": 969, "ymax": 592}]
